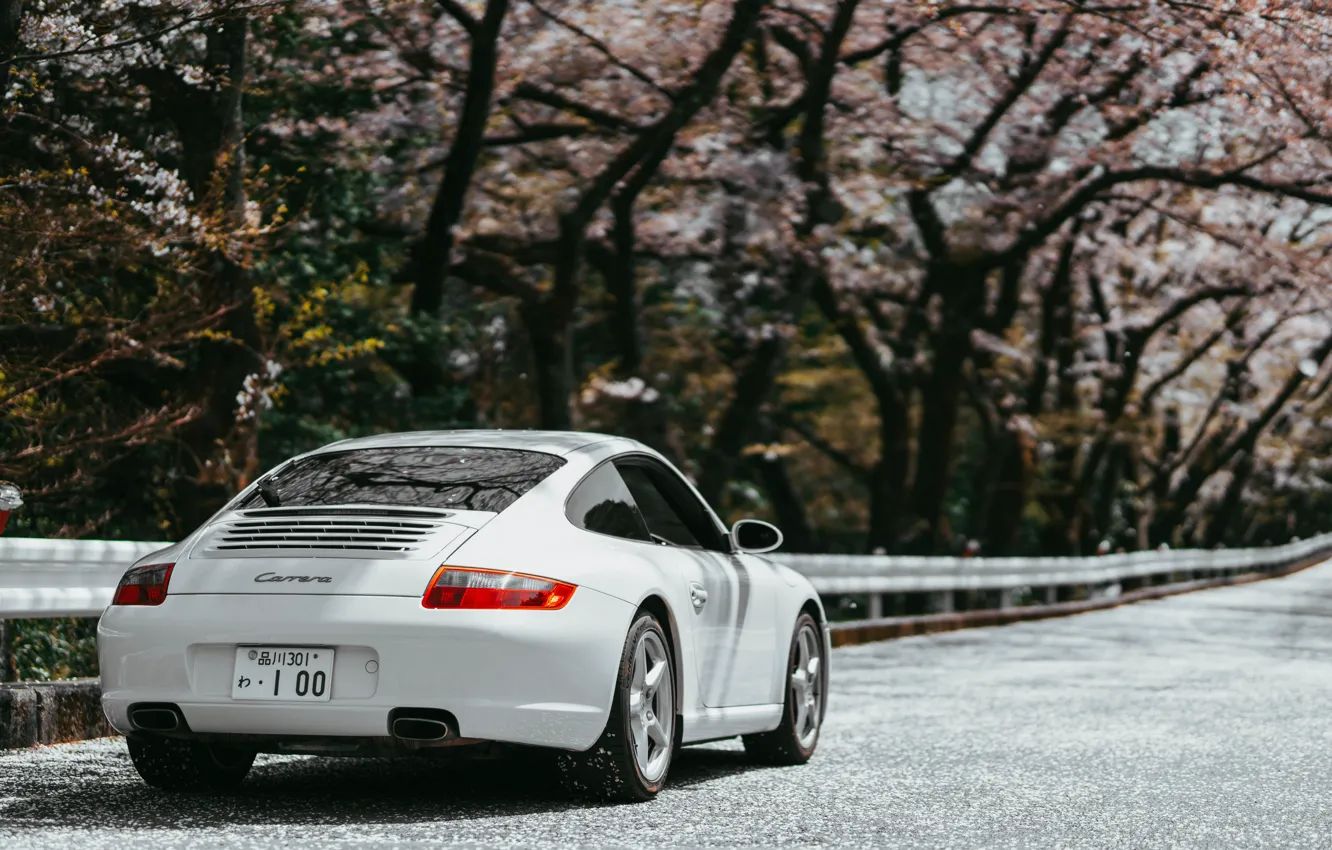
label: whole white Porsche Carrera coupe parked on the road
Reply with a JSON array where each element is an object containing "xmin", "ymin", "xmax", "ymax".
[{"xmin": 97, "ymin": 430, "xmax": 829, "ymax": 799}]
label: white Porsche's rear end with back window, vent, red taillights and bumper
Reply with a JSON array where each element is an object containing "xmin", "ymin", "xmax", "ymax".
[{"xmin": 99, "ymin": 448, "xmax": 634, "ymax": 761}]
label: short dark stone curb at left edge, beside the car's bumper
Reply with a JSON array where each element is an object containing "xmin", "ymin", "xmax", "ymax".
[{"xmin": 0, "ymin": 679, "xmax": 116, "ymax": 750}]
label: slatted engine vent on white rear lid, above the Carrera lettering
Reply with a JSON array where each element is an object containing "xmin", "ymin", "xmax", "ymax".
[{"xmin": 206, "ymin": 510, "xmax": 448, "ymax": 557}]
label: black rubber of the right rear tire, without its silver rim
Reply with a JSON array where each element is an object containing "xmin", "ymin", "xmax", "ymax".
[{"xmin": 557, "ymin": 612, "xmax": 679, "ymax": 802}]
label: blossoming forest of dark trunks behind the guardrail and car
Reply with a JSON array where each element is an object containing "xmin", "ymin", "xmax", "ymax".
[{"xmin": 0, "ymin": 0, "xmax": 1332, "ymax": 580}]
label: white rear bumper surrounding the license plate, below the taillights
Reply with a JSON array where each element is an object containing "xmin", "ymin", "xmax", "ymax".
[{"xmin": 97, "ymin": 588, "xmax": 634, "ymax": 750}]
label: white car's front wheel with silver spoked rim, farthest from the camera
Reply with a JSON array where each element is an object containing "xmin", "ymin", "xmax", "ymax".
[{"xmin": 743, "ymin": 612, "xmax": 829, "ymax": 765}]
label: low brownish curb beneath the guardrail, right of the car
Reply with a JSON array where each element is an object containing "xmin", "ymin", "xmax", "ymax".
[{"xmin": 831, "ymin": 557, "xmax": 1327, "ymax": 646}]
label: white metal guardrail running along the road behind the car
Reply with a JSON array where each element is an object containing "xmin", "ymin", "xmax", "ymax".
[{"xmin": 0, "ymin": 534, "xmax": 1332, "ymax": 620}]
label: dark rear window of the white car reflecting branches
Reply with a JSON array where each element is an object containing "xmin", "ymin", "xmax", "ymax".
[{"xmin": 241, "ymin": 446, "xmax": 565, "ymax": 513}]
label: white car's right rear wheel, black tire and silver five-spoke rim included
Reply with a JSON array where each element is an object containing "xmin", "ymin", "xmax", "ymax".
[{"xmin": 557, "ymin": 612, "xmax": 677, "ymax": 802}]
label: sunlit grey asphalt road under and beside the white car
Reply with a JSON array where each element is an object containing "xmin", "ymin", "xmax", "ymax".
[{"xmin": 0, "ymin": 565, "xmax": 1332, "ymax": 850}]
